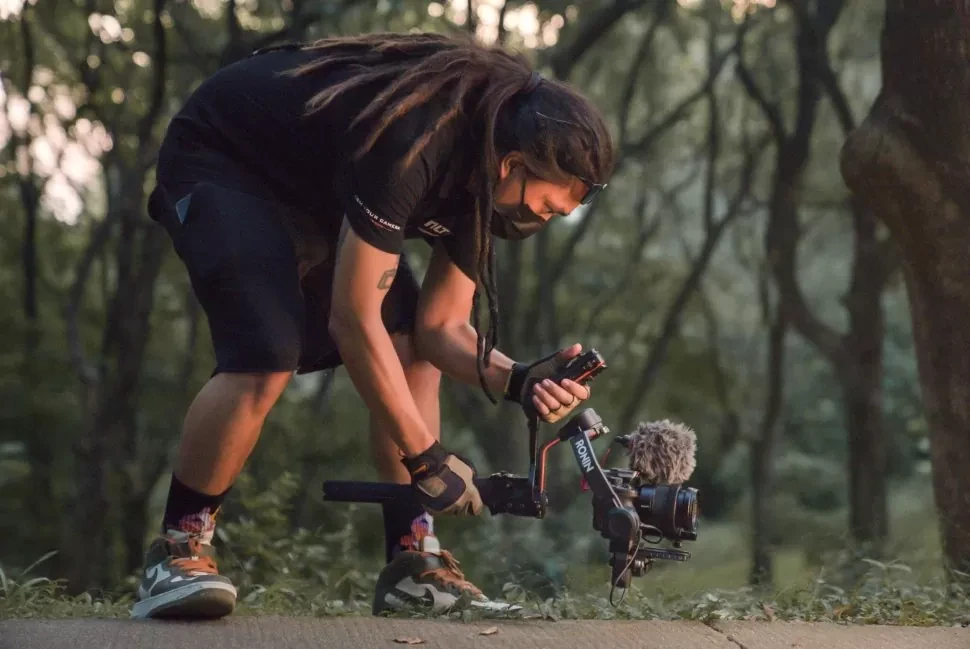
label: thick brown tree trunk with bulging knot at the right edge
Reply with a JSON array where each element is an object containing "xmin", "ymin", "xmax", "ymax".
[{"xmin": 841, "ymin": 0, "xmax": 970, "ymax": 574}]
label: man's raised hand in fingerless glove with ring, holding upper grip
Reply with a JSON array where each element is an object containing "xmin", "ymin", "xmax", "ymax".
[{"xmin": 507, "ymin": 343, "xmax": 590, "ymax": 424}]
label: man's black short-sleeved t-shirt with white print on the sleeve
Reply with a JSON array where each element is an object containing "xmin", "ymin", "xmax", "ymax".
[{"xmin": 169, "ymin": 45, "xmax": 477, "ymax": 278}]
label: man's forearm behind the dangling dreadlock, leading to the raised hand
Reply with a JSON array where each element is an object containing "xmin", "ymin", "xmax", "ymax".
[{"xmin": 415, "ymin": 323, "xmax": 514, "ymax": 396}]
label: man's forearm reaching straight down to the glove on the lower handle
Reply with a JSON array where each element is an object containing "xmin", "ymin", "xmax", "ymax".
[{"xmin": 330, "ymin": 318, "xmax": 435, "ymax": 457}]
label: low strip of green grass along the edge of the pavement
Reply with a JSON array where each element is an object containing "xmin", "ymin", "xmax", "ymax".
[{"xmin": 0, "ymin": 564, "xmax": 970, "ymax": 626}]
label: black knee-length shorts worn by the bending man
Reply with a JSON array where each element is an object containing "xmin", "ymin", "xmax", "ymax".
[{"xmin": 149, "ymin": 146, "xmax": 419, "ymax": 374}]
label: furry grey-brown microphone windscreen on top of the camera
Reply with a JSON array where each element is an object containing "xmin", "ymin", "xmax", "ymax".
[{"xmin": 625, "ymin": 419, "xmax": 697, "ymax": 484}]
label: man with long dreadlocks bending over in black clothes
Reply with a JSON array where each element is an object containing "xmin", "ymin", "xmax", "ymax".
[{"xmin": 132, "ymin": 34, "xmax": 613, "ymax": 618}]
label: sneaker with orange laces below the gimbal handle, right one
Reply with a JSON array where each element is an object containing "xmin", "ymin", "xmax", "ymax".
[{"xmin": 373, "ymin": 537, "xmax": 522, "ymax": 615}]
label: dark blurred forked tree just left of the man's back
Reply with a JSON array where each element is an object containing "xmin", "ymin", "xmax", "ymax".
[{"xmin": 48, "ymin": 0, "xmax": 181, "ymax": 591}]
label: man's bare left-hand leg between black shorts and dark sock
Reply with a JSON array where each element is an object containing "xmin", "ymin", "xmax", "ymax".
[{"xmin": 175, "ymin": 372, "xmax": 292, "ymax": 495}]
